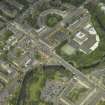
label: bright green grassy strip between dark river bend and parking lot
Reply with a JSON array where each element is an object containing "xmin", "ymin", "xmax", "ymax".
[{"xmin": 16, "ymin": 69, "xmax": 47, "ymax": 105}]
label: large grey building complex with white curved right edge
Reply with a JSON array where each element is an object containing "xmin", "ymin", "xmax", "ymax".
[{"xmin": 69, "ymin": 24, "xmax": 100, "ymax": 54}]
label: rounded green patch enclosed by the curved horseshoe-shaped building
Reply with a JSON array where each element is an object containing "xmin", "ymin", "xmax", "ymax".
[{"xmin": 46, "ymin": 14, "xmax": 62, "ymax": 27}]
